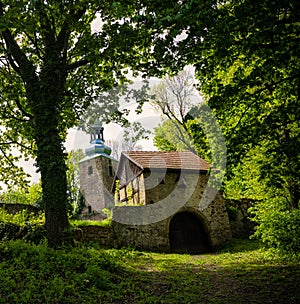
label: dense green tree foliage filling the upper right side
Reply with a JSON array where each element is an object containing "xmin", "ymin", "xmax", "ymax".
[{"xmin": 152, "ymin": 0, "xmax": 300, "ymax": 208}]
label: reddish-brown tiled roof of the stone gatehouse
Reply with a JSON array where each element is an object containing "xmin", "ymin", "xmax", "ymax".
[{"xmin": 122, "ymin": 151, "xmax": 211, "ymax": 171}]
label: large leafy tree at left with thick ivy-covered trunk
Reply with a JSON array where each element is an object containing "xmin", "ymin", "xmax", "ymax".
[{"xmin": 0, "ymin": 0, "xmax": 164, "ymax": 247}]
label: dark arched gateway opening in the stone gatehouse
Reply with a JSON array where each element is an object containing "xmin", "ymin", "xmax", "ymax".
[{"xmin": 169, "ymin": 211, "xmax": 211, "ymax": 254}]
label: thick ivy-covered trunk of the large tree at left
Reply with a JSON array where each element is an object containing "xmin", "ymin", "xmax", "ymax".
[{"xmin": 32, "ymin": 58, "xmax": 69, "ymax": 248}]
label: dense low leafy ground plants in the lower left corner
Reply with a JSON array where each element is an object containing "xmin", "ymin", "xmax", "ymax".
[{"xmin": 0, "ymin": 240, "xmax": 121, "ymax": 303}]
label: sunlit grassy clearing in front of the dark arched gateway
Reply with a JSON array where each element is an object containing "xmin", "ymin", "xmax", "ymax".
[{"xmin": 105, "ymin": 240, "xmax": 300, "ymax": 304}]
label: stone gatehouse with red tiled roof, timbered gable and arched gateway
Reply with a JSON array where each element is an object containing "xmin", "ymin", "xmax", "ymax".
[{"xmin": 113, "ymin": 151, "xmax": 231, "ymax": 253}]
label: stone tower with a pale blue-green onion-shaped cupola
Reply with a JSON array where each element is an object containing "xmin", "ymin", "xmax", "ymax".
[{"xmin": 79, "ymin": 123, "xmax": 118, "ymax": 218}]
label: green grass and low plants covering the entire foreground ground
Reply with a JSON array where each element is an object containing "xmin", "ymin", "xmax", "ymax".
[{"xmin": 0, "ymin": 240, "xmax": 300, "ymax": 304}]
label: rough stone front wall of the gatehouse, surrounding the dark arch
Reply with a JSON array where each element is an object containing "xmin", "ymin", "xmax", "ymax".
[{"xmin": 80, "ymin": 170, "xmax": 232, "ymax": 252}]
